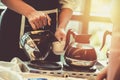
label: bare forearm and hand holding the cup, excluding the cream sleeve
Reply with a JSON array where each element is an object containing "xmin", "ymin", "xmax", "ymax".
[{"xmin": 55, "ymin": 8, "xmax": 72, "ymax": 41}]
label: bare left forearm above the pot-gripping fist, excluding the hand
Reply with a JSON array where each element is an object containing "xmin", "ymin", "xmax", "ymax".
[{"xmin": 1, "ymin": 0, "xmax": 36, "ymax": 17}]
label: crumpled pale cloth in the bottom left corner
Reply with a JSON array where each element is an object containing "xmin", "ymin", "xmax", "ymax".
[{"xmin": 0, "ymin": 57, "xmax": 29, "ymax": 80}]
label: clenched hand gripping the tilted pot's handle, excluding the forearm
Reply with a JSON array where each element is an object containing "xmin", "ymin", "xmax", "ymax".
[{"xmin": 27, "ymin": 11, "xmax": 51, "ymax": 30}]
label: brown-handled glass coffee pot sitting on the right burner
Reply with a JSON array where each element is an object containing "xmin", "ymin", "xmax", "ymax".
[{"xmin": 64, "ymin": 29, "xmax": 97, "ymax": 68}]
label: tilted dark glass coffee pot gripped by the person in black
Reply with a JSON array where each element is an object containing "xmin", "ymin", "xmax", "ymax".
[{"xmin": 20, "ymin": 30, "xmax": 56, "ymax": 61}]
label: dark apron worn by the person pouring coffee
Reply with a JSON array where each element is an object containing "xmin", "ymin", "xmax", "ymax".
[{"xmin": 0, "ymin": 0, "xmax": 60, "ymax": 62}]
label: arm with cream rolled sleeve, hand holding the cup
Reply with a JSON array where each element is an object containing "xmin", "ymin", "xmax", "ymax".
[{"xmin": 55, "ymin": 0, "xmax": 76, "ymax": 41}]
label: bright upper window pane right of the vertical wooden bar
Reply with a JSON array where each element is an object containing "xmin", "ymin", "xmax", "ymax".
[{"xmin": 90, "ymin": 0, "xmax": 111, "ymax": 17}]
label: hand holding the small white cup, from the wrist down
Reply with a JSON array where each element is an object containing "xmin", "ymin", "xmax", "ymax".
[{"xmin": 55, "ymin": 27, "xmax": 66, "ymax": 41}]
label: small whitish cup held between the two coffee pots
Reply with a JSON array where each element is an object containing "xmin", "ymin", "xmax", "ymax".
[{"xmin": 52, "ymin": 41, "xmax": 65, "ymax": 55}]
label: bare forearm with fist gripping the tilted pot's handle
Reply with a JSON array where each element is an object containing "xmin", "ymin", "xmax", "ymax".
[{"xmin": 1, "ymin": 0, "xmax": 51, "ymax": 30}]
